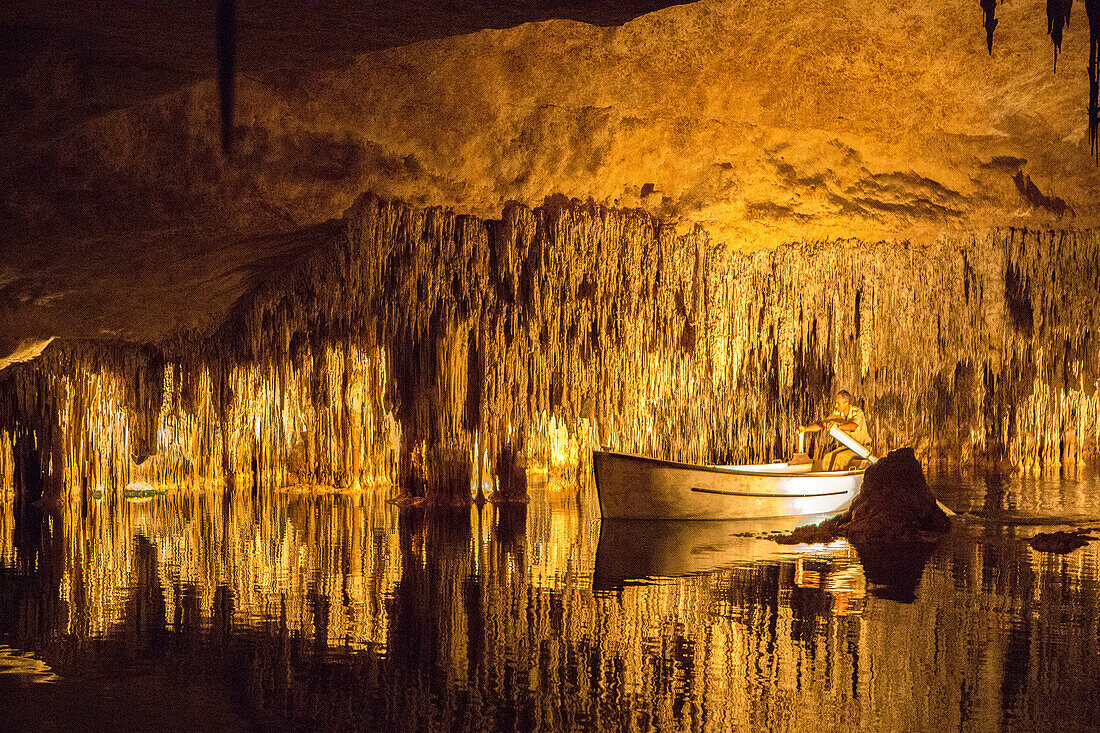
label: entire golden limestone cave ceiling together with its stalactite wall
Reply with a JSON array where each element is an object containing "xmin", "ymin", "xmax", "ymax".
[{"xmin": 0, "ymin": 0, "xmax": 1100, "ymax": 503}]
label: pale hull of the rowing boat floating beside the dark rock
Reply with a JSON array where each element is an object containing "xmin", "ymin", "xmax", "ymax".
[{"xmin": 593, "ymin": 450, "xmax": 864, "ymax": 519}]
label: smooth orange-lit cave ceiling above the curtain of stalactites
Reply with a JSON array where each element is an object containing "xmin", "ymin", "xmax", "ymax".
[{"xmin": 0, "ymin": 0, "xmax": 1100, "ymax": 367}]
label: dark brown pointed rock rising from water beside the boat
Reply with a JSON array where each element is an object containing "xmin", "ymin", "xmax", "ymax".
[{"xmin": 774, "ymin": 448, "xmax": 950, "ymax": 545}]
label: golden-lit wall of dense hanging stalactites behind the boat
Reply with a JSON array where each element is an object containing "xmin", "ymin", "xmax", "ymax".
[{"xmin": 0, "ymin": 196, "xmax": 1100, "ymax": 503}]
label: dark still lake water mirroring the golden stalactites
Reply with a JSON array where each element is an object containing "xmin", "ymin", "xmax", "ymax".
[{"xmin": 0, "ymin": 475, "xmax": 1100, "ymax": 731}]
